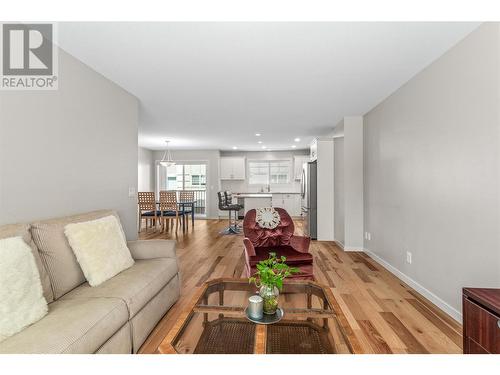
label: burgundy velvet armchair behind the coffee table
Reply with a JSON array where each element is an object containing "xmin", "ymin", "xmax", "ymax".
[{"xmin": 243, "ymin": 207, "xmax": 314, "ymax": 280}]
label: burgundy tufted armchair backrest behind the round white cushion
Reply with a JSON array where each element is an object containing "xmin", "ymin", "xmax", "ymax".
[{"xmin": 243, "ymin": 207, "xmax": 295, "ymax": 247}]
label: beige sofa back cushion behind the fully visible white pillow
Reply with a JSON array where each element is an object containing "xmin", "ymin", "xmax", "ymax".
[{"xmin": 31, "ymin": 210, "xmax": 122, "ymax": 299}]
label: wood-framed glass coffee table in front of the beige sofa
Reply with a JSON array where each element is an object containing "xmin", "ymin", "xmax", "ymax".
[{"xmin": 158, "ymin": 279, "xmax": 362, "ymax": 354}]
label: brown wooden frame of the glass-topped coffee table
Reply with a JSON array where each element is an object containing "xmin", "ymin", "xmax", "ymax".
[{"xmin": 157, "ymin": 278, "xmax": 363, "ymax": 354}]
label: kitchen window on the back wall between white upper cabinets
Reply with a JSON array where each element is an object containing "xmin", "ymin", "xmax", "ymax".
[{"xmin": 248, "ymin": 160, "xmax": 291, "ymax": 185}]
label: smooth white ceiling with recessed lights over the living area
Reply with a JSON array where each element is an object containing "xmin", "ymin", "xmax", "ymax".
[{"xmin": 59, "ymin": 22, "xmax": 478, "ymax": 150}]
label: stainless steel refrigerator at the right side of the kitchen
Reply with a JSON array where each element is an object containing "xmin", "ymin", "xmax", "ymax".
[{"xmin": 301, "ymin": 161, "xmax": 318, "ymax": 239}]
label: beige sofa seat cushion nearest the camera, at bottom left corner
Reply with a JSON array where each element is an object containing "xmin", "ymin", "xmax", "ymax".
[{"xmin": 0, "ymin": 298, "xmax": 128, "ymax": 353}]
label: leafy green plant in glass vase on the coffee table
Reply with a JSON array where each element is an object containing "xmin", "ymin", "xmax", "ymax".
[{"xmin": 249, "ymin": 253, "xmax": 300, "ymax": 314}]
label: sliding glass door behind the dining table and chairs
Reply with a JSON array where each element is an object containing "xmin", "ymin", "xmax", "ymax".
[{"xmin": 157, "ymin": 161, "xmax": 207, "ymax": 215}]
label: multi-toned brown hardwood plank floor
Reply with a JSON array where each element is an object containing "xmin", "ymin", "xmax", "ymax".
[{"xmin": 136, "ymin": 220, "xmax": 462, "ymax": 353}]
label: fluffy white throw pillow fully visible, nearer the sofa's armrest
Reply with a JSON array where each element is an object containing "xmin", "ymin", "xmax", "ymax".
[{"xmin": 64, "ymin": 216, "xmax": 134, "ymax": 286}]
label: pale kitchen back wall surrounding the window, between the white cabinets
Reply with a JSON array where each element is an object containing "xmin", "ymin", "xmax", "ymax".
[{"xmin": 221, "ymin": 150, "xmax": 309, "ymax": 193}]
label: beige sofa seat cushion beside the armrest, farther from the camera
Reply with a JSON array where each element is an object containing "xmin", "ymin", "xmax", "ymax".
[{"xmin": 62, "ymin": 258, "xmax": 178, "ymax": 318}]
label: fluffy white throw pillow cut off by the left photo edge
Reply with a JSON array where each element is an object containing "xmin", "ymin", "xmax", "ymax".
[{"xmin": 0, "ymin": 237, "xmax": 48, "ymax": 342}]
